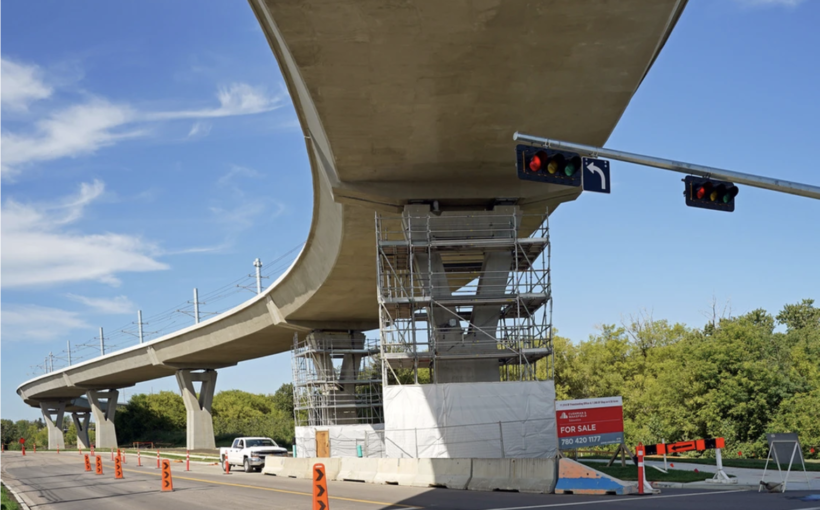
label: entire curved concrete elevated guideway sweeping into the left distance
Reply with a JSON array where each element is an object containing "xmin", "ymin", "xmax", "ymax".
[{"xmin": 17, "ymin": 0, "xmax": 685, "ymax": 442}]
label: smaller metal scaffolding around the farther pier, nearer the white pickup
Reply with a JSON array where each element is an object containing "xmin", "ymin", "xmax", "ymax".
[{"xmin": 291, "ymin": 333, "xmax": 384, "ymax": 427}]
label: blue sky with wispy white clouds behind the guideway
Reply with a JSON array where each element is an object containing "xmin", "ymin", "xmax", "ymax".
[{"xmin": 2, "ymin": 0, "xmax": 820, "ymax": 419}]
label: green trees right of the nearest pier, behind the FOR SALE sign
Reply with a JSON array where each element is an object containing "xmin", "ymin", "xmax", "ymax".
[{"xmin": 538, "ymin": 299, "xmax": 820, "ymax": 458}]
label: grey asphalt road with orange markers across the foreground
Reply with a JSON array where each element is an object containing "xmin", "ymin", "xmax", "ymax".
[{"xmin": 0, "ymin": 452, "xmax": 820, "ymax": 510}]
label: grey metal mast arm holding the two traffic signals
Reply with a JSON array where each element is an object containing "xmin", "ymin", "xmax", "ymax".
[{"xmin": 513, "ymin": 131, "xmax": 820, "ymax": 200}]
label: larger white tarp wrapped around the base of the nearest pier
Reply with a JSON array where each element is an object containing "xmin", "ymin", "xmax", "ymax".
[{"xmin": 383, "ymin": 381, "xmax": 558, "ymax": 458}]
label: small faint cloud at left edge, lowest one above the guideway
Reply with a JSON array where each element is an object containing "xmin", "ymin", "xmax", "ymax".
[{"xmin": 2, "ymin": 303, "xmax": 91, "ymax": 342}]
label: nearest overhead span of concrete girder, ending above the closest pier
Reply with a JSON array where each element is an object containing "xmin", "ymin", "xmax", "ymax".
[{"xmin": 250, "ymin": 0, "xmax": 685, "ymax": 207}]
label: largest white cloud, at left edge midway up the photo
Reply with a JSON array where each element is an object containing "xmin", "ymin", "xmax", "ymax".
[{"xmin": 2, "ymin": 181, "xmax": 168, "ymax": 287}]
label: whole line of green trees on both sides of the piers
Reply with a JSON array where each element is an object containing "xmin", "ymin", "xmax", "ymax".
[{"xmin": 2, "ymin": 299, "xmax": 820, "ymax": 458}]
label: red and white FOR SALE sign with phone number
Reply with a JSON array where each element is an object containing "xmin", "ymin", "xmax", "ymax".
[{"xmin": 555, "ymin": 397, "xmax": 624, "ymax": 450}]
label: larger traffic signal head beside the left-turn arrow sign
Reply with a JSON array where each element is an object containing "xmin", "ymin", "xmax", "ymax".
[{"xmin": 515, "ymin": 145, "xmax": 581, "ymax": 186}]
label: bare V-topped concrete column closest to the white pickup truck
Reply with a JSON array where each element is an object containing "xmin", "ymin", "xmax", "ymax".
[{"xmin": 177, "ymin": 369, "xmax": 216, "ymax": 450}]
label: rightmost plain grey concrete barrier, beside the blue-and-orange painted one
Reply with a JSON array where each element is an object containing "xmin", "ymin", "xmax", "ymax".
[{"xmin": 467, "ymin": 458, "xmax": 558, "ymax": 494}]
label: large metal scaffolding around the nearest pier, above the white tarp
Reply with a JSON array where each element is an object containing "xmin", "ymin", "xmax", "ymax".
[{"xmin": 376, "ymin": 206, "xmax": 554, "ymax": 384}]
